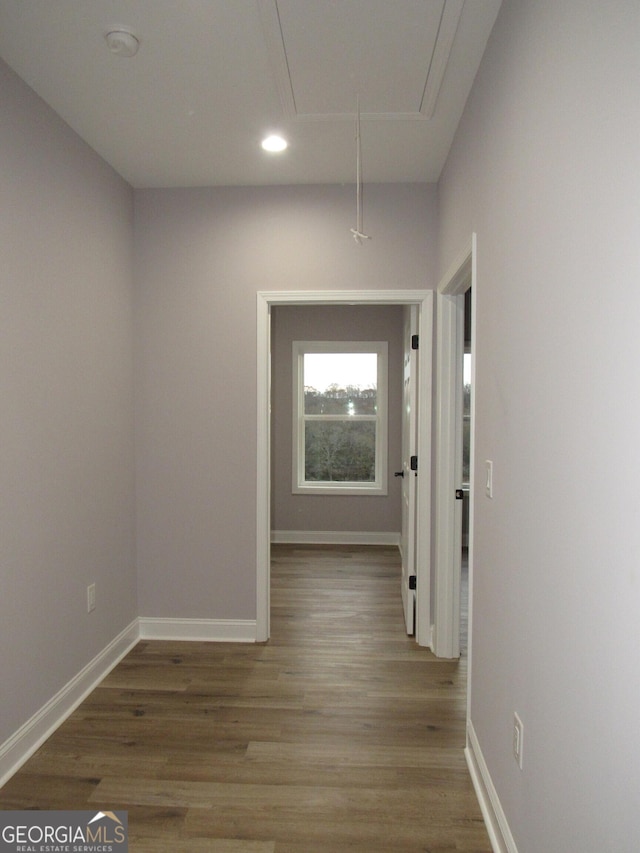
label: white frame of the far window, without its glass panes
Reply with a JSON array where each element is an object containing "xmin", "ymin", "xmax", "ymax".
[{"xmin": 292, "ymin": 341, "xmax": 389, "ymax": 495}]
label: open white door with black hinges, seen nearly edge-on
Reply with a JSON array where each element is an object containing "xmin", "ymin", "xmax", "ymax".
[{"xmin": 397, "ymin": 305, "xmax": 418, "ymax": 634}]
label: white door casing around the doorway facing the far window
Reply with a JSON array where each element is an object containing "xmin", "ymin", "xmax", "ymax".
[{"xmin": 256, "ymin": 290, "xmax": 433, "ymax": 646}]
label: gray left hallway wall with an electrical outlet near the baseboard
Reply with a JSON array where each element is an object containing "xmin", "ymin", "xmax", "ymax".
[{"xmin": 0, "ymin": 62, "xmax": 137, "ymax": 743}]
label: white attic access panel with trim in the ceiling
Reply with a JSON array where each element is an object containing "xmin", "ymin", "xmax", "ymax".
[{"xmin": 260, "ymin": 0, "xmax": 464, "ymax": 121}]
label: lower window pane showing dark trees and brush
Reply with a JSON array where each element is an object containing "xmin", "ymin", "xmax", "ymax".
[{"xmin": 304, "ymin": 420, "xmax": 376, "ymax": 483}]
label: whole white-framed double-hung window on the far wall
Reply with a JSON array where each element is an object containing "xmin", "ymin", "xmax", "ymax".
[{"xmin": 293, "ymin": 341, "xmax": 387, "ymax": 495}]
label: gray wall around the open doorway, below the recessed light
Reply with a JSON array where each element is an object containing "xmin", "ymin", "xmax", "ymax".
[{"xmin": 135, "ymin": 185, "xmax": 436, "ymax": 619}]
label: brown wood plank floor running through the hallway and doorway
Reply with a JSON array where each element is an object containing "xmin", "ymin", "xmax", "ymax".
[{"xmin": 0, "ymin": 545, "xmax": 491, "ymax": 853}]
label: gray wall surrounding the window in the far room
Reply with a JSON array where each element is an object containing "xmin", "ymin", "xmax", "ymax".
[{"xmin": 271, "ymin": 305, "xmax": 404, "ymax": 534}]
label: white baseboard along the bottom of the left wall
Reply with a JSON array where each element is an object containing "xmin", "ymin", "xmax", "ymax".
[{"xmin": 0, "ymin": 619, "xmax": 138, "ymax": 788}]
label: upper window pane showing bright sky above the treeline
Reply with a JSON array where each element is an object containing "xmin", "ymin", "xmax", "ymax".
[{"xmin": 303, "ymin": 353, "xmax": 378, "ymax": 415}]
